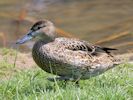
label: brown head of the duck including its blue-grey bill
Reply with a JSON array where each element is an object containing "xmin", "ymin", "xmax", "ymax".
[{"xmin": 16, "ymin": 20, "xmax": 56, "ymax": 44}]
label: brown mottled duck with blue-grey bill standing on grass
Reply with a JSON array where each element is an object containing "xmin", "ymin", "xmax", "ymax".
[{"xmin": 16, "ymin": 20, "xmax": 121, "ymax": 81}]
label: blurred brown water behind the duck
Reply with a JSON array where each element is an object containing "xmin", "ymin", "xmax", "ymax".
[{"xmin": 0, "ymin": 0, "xmax": 133, "ymax": 53}]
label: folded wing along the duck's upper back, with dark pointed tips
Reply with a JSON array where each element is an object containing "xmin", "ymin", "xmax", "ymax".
[{"xmin": 56, "ymin": 38, "xmax": 117, "ymax": 54}]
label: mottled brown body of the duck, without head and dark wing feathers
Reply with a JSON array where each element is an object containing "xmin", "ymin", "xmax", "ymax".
[{"xmin": 32, "ymin": 38, "xmax": 120, "ymax": 79}]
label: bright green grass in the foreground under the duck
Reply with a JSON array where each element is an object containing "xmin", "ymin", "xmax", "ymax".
[{"xmin": 0, "ymin": 50, "xmax": 133, "ymax": 100}]
